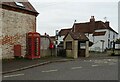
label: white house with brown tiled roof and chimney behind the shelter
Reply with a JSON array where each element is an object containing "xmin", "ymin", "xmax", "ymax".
[{"xmin": 58, "ymin": 16, "xmax": 118, "ymax": 52}]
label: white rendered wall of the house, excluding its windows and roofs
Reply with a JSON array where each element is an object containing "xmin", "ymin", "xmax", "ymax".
[{"xmin": 88, "ymin": 29, "xmax": 118, "ymax": 52}]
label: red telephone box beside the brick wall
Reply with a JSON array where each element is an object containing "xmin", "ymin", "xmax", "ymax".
[{"xmin": 26, "ymin": 32, "xmax": 40, "ymax": 59}]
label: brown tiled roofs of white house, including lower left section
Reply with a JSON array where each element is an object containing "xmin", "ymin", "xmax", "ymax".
[{"xmin": 59, "ymin": 17, "xmax": 118, "ymax": 36}]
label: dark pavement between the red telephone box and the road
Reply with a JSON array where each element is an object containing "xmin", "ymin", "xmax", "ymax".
[{"xmin": 2, "ymin": 57, "xmax": 73, "ymax": 74}]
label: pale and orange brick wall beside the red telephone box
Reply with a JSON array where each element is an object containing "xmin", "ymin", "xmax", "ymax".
[{"xmin": 1, "ymin": 9, "xmax": 36, "ymax": 59}]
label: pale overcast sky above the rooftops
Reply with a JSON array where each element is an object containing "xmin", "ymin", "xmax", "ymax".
[{"xmin": 29, "ymin": 0, "xmax": 118, "ymax": 35}]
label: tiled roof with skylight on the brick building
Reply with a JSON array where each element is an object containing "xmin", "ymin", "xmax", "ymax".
[{"xmin": 1, "ymin": 2, "xmax": 39, "ymax": 16}]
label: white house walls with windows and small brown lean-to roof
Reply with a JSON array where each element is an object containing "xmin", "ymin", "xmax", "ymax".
[{"xmin": 89, "ymin": 29, "xmax": 118, "ymax": 52}]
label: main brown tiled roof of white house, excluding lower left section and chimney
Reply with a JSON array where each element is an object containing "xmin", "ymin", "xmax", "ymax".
[{"xmin": 72, "ymin": 21, "xmax": 118, "ymax": 34}]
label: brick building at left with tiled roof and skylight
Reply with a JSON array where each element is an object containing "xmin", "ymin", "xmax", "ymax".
[{"xmin": 0, "ymin": 2, "xmax": 39, "ymax": 58}]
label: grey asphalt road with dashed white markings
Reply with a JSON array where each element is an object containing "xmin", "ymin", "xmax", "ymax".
[{"xmin": 3, "ymin": 57, "xmax": 118, "ymax": 80}]
